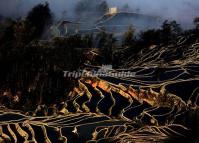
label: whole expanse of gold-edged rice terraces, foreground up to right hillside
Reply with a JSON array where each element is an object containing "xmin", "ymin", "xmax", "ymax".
[{"xmin": 0, "ymin": 36, "xmax": 199, "ymax": 143}]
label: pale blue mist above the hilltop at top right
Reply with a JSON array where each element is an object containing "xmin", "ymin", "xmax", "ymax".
[{"xmin": 107, "ymin": 0, "xmax": 199, "ymax": 26}]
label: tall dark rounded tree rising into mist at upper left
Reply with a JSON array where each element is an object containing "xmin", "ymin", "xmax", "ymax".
[{"xmin": 26, "ymin": 2, "xmax": 52, "ymax": 38}]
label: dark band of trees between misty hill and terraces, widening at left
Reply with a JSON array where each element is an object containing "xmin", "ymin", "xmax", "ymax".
[{"xmin": 0, "ymin": 10, "xmax": 199, "ymax": 109}]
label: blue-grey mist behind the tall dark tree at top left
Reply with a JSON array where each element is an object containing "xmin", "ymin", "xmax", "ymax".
[{"xmin": 0, "ymin": 0, "xmax": 78, "ymax": 18}]
